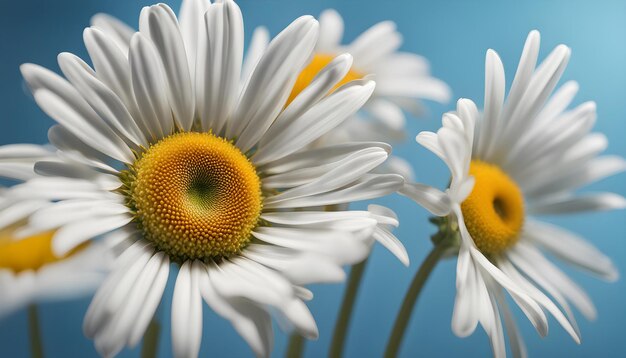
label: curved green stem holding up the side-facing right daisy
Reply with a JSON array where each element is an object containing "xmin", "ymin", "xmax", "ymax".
[{"xmin": 385, "ymin": 244, "xmax": 450, "ymax": 358}]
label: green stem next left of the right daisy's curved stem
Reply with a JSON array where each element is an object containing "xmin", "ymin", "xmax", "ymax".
[{"xmin": 328, "ymin": 259, "xmax": 367, "ymax": 358}]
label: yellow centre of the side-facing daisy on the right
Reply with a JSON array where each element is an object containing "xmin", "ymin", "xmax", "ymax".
[{"xmin": 461, "ymin": 160, "xmax": 524, "ymax": 255}]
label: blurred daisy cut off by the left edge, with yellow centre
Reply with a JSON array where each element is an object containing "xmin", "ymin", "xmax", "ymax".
[{"xmin": 0, "ymin": 144, "xmax": 113, "ymax": 317}]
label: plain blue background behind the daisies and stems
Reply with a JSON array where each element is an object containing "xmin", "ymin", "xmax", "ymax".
[{"xmin": 0, "ymin": 0, "xmax": 626, "ymax": 357}]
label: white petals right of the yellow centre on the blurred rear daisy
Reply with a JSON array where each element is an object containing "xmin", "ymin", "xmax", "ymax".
[{"xmin": 309, "ymin": 9, "xmax": 450, "ymax": 142}]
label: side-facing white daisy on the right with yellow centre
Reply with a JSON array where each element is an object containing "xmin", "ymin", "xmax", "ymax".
[{"xmin": 402, "ymin": 31, "xmax": 626, "ymax": 357}]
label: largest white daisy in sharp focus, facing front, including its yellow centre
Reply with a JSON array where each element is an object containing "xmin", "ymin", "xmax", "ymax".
[{"xmin": 15, "ymin": 1, "xmax": 406, "ymax": 357}]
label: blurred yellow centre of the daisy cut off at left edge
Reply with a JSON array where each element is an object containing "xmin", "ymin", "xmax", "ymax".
[{"xmin": 0, "ymin": 230, "xmax": 85, "ymax": 273}]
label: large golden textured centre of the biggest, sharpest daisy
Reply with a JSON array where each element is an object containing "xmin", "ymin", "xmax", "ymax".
[{"xmin": 123, "ymin": 132, "xmax": 263, "ymax": 262}]
